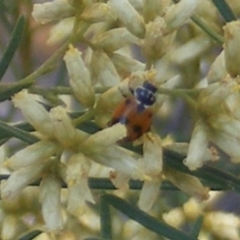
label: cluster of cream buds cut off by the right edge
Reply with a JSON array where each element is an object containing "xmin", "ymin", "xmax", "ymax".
[{"xmin": 185, "ymin": 21, "xmax": 240, "ymax": 170}]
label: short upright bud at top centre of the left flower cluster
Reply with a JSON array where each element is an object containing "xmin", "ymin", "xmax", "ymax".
[{"xmin": 49, "ymin": 106, "xmax": 86, "ymax": 149}]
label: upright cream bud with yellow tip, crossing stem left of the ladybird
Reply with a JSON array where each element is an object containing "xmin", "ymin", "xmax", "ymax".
[{"xmin": 64, "ymin": 45, "xmax": 95, "ymax": 107}]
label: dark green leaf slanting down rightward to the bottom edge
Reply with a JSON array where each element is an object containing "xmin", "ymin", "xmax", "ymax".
[{"xmin": 102, "ymin": 194, "xmax": 197, "ymax": 240}]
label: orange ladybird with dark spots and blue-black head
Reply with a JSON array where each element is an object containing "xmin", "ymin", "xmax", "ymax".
[{"xmin": 108, "ymin": 81, "xmax": 157, "ymax": 141}]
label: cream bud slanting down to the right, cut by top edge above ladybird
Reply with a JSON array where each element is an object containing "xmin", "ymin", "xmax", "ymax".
[{"xmin": 109, "ymin": 0, "xmax": 145, "ymax": 38}]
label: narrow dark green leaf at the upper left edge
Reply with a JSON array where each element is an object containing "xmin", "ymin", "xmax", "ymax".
[{"xmin": 0, "ymin": 16, "xmax": 25, "ymax": 80}]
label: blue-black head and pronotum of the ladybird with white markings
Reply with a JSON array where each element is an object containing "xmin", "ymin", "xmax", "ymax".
[{"xmin": 133, "ymin": 81, "xmax": 157, "ymax": 108}]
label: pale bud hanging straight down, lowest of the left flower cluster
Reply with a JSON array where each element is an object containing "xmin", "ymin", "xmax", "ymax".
[{"xmin": 40, "ymin": 175, "xmax": 63, "ymax": 231}]
